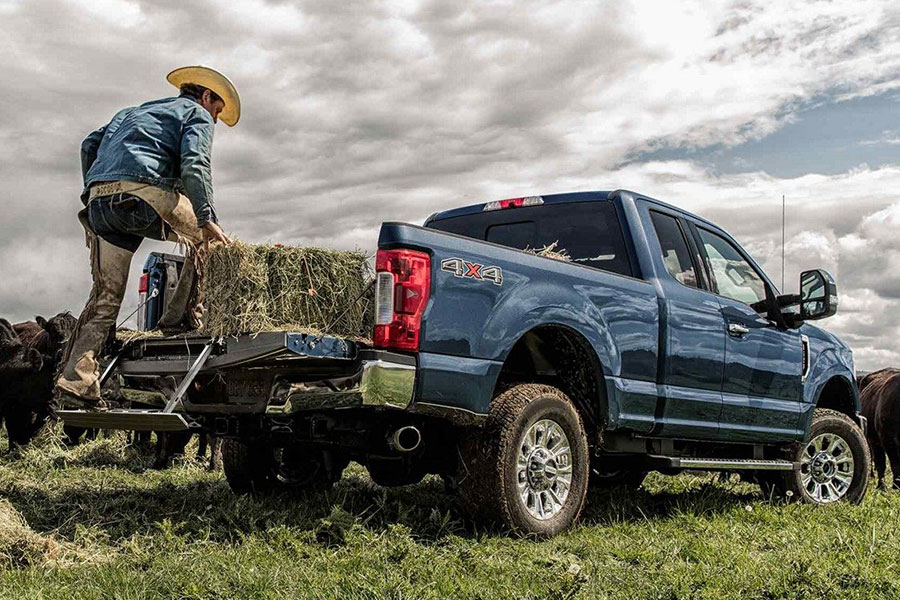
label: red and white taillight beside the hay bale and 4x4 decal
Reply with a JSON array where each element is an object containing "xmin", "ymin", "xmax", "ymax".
[{"xmin": 374, "ymin": 250, "xmax": 431, "ymax": 350}]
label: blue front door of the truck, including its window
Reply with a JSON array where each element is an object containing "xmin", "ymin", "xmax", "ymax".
[{"xmin": 694, "ymin": 225, "xmax": 803, "ymax": 441}]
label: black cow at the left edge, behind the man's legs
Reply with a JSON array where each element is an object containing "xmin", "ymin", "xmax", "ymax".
[{"xmin": 0, "ymin": 312, "xmax": 76, "ymax": 445}]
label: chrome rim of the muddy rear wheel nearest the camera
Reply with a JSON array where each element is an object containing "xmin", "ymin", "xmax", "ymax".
[{"xmin": 516, "ymin": 419, "xmax": 572, "ymax": 521}]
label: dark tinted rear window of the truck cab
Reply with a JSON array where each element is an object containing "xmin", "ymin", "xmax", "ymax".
[{"xmin": 428, "ymin": 200, "xmax": 634, "ymax": 277}]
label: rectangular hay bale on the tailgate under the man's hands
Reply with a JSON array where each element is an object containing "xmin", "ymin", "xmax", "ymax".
[{"xmin": 200, "ymin": 242, "xmax": 371, "ymax": 337}]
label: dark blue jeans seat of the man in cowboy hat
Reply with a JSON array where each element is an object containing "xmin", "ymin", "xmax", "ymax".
[{"xmin": 88, "ymin": 194, "xmax": 170, "ymax": 252}]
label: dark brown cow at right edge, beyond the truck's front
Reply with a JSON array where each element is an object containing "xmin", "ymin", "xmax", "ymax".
[{"xmin": 859, "ymin": 369, "xmax": 900, "ymax": 489}]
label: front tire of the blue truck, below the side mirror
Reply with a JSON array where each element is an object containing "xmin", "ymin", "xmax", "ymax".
[{"xmin": 780, "ymin": 408, "xmax": 872, "ymax": 504}]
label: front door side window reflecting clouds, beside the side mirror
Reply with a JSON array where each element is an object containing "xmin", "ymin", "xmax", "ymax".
[{"xmin": 697, "ymin": 227, "xmax": 766, "ymax": 304}]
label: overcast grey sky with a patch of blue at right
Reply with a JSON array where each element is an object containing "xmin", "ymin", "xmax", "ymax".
[{"xmin": 0, "ymin": 0, "xmax": 900, "ymax": 370}]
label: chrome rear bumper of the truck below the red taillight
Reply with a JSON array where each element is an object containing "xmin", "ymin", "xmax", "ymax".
[{"xmin": 266, "ymin": 351, "xmax": 416, "ymax": 415}]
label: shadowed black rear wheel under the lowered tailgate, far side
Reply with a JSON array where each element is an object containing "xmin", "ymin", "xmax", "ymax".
[{"xmin": 222, "ymin": 439, "xmax": 349, "ymax": 494}]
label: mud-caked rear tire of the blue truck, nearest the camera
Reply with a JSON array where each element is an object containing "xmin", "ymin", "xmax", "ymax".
[{"xmin": 459, "ymin": 384, "xmax": 590, "ymax": 537}]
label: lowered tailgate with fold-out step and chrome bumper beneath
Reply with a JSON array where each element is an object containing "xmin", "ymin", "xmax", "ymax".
[{"xmin": 58, "ymin": 332, "xmax": 416, "ymax": 431}]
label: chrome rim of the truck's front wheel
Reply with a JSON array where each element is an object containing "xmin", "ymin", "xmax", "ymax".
[{"xmin": 800, "ymin": 433, "xmax": 853, "ymax": 504}]
